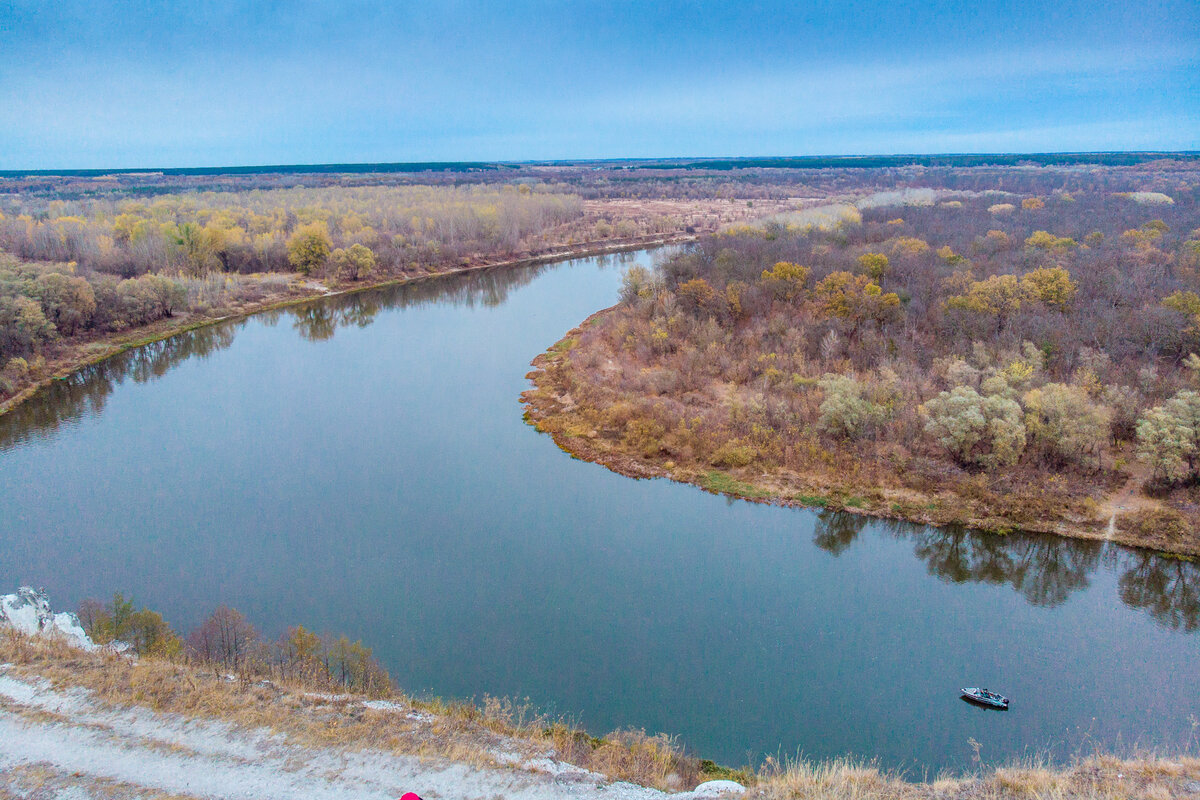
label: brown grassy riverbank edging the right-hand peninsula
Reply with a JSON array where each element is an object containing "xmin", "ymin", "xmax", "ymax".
[{"xmin": 522, "ymin": 307, "xmax": 1200, "ymax": 558}]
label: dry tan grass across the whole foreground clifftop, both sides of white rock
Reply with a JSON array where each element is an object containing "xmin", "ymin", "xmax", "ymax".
[{"xmin": 0, "ymin": 631, "xmax": 1200, "ymax": 800}]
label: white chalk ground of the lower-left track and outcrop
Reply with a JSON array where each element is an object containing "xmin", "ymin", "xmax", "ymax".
[{"xmin": 0, "ymin": 593, "xmax": 743, "ymax": 800}]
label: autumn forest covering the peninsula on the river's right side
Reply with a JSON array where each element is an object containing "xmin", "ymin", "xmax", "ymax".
[{"xmin": 527, "ymin": 163, "xmax": 1200, "ymax": 552}]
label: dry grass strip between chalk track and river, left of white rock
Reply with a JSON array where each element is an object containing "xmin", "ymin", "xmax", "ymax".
[{"xmin": 0, "ymin": 630, "xmax": 706, "ymax": 789}]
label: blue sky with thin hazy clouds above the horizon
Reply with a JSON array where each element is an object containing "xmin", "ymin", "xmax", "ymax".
[{"xmin": 0, "ymin": 0, "xmax": 1200, "ymax": 169}]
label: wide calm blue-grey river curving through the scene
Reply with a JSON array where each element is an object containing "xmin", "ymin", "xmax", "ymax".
[{"xmin": 0, "ymin": 253, "xmax": 1200, "ymax": 777}]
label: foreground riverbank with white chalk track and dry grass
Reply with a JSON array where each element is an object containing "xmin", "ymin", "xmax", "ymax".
[{"xmin": 0, "ymin": 630, "xmax": 1200, "ymax": 800}]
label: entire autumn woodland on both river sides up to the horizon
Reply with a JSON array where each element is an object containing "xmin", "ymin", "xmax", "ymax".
[{"xmin": 7, "ymin": 156, "xmax": 1200, "ymax": 549}]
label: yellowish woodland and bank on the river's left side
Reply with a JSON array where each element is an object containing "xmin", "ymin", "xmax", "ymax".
[{"xmin": 0, "ymin": 174, "xmax": 733, "ymax": 401}]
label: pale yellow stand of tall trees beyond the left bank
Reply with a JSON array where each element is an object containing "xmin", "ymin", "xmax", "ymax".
[{"xmin": 0, "ymin": 185, "xmax": 582, "ymax": 277}]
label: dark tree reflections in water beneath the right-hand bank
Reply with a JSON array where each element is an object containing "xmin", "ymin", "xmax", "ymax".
[{"xmin": 812, "ymin": 511, "xmax": 1200, "ymax": 632}]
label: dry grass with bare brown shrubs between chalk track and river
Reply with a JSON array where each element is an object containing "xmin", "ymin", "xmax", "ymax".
[{"xmin": 0, "ymin": 614, "xmax": 710, "ymax": 789}]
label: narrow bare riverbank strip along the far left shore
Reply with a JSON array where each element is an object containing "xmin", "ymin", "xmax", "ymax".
[{"xmin": 0, "ymin": 234, "xmax": 697, "ymax": 416}]
